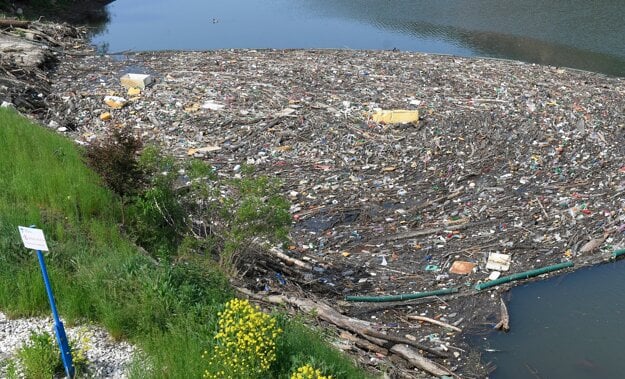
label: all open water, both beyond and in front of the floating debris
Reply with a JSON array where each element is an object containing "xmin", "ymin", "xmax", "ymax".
[{"xmin": 89, "ymin": 0, "xmax": 625, "ymax": 379}]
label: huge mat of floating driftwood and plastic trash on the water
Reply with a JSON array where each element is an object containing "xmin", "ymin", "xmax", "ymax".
[{"xmin": 2, "ymin": 22, "xmax": 625, "ymax": 377}]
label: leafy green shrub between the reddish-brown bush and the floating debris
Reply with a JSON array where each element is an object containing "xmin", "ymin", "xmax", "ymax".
[{"xmin": 128, "ymin": 147, "xmax": 291, "ymax": 271}]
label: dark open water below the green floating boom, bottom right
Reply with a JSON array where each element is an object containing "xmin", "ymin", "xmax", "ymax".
[{"xmin": 485, "ymin": 261, "xmax": 625, "ymax": 379}]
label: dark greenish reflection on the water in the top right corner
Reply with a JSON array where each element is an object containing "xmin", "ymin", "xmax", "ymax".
[{"xmin": 305, "ymin": 0, "xmax": 625, "ymax": 76}]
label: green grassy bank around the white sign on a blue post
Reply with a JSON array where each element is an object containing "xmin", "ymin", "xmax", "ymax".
[{"xmin": 0, "ymin": 109, "xmax": 366, "ymax": 378}]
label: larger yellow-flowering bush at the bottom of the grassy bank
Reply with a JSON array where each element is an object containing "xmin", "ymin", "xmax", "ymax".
[{"xmin": 203, "ymin": 299, "xmax": 282, "ymax": 379}]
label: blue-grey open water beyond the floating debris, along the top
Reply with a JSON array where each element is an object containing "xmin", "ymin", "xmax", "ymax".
[{"xmin": 94, "ymin": 0, "xmax": 625, "ymax": 76}]
